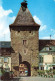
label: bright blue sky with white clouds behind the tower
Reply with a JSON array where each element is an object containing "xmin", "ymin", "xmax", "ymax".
[{"xmin": 0, "ymin": 0, "xmax": 55, "ymax": 41}]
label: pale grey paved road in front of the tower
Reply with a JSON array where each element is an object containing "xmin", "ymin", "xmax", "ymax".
[{"xmin": 0, "ymin": 77, "xmax": 55, "ymax": 81}]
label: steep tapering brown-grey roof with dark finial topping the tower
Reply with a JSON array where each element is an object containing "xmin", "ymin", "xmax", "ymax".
[{"xmin": 10, "ymin": 2, "xmax": 40, "ymax": 27}]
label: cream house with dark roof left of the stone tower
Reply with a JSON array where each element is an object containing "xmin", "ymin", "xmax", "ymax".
[{"xmin": 0, "ymin": 41, "xmax": 11, "ymax": 72}]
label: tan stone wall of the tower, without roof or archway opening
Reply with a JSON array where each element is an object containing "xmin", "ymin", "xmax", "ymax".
[{"xmin": 11, "ymin": 27, "xmax": 39, "ymax": 76}]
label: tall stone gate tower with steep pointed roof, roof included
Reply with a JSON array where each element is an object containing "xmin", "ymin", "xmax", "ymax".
[{"xmin": 10, "ymin": 2, "xmax": 40, "ymax": 76}]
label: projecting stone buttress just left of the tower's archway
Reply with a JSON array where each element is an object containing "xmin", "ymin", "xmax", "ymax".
[{"xmin": 11, "ymin": 53, "xmax": 19, "ymax": 77}]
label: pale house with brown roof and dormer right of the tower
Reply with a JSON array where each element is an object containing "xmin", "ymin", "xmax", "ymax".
[{"xmin": 39, "ymin": 40, "xmax": 55, "ymax": 70}]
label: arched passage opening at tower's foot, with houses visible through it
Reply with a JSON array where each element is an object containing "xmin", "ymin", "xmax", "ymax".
[{"xmin": 19, "ymin": 61, "xmax": 31, "ymax": 76}]
